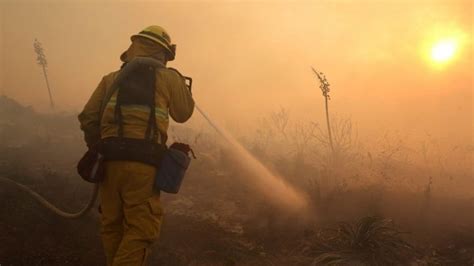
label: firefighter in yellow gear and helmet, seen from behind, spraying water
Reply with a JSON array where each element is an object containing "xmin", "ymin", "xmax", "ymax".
[{"xmin": 79, "ymin": 26, "xmax": 194, "ymax": 266}]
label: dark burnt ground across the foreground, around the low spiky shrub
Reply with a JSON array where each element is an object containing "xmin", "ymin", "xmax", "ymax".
[{"xmin": 0, "ymin": 169, "xmax": 474, "ymax": 265}]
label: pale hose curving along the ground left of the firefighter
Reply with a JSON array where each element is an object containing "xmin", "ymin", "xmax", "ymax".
[{"xmin": 0, "ymin": 176, "xmax": 99, "ymax": 219}]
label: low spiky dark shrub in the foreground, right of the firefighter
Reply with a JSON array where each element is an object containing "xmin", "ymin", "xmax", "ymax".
[{"xmin": 302, "ymin": 216, "xmax": 415, "ymax": 265}]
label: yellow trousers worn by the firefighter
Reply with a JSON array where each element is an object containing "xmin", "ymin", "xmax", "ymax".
[{"xmin": 99, "ymin": 161, "xmax": 162, "ymax": 266}]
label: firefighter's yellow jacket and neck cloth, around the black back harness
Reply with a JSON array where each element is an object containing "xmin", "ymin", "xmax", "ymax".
[{"xmin": 78, "ymin": 38, "xmax": 194, "ymax": 147}]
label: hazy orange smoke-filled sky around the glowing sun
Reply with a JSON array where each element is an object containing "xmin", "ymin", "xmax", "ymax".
[{"xmin": 0, "ymin": 0, "xmax": 474, "ymax": 142}]
